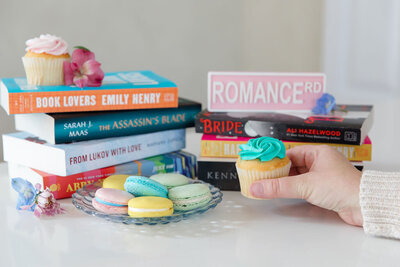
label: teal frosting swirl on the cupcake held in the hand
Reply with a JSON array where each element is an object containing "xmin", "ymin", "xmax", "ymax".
[{"xmin": 239, "ymin": 137, "xmax": 286, "ymax": 161}]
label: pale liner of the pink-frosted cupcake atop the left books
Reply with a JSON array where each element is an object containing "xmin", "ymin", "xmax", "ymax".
[{"xmin": 22, "ymin": 57, "xmax": 68, "ymax": 85}]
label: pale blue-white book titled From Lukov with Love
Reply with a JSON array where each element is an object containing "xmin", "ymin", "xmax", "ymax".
[{"xmin": 3, "ymin": 129, "xmax": 185, "ymax": 176}]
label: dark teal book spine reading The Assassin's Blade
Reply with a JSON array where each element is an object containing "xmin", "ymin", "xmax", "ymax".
[{"xmin": 54, "ymin": 105, "xmax": 201, "ymax": 144}]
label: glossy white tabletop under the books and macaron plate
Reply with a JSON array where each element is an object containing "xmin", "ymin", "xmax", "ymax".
[{"xmin": 0, "ymin": 93, "xmax": 400, "ymax": 267}]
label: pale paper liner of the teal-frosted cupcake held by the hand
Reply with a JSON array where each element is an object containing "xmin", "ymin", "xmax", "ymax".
[{"xmin": 236, "ymin": 161, "xmax": 292, "ymax": 199}]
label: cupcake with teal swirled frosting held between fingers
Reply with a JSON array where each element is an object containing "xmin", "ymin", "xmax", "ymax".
[{"xmin": 236, "ymin": 137, "xmax": 291, "ymax": 198}]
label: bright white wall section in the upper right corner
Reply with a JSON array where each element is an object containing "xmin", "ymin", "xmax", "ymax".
[{"xmin": 323, "ymin": 0, "xmax": 400, "ymax": 96}]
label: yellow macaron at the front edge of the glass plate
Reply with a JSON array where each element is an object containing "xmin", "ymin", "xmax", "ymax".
[{"xmin": 128, "ymin": 197, "xmax": 174, "ymax": 218}]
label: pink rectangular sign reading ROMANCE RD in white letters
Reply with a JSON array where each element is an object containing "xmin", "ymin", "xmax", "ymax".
[{"xmin": 208, "ymin": 72, "xmax": 326, "ymax": 112}]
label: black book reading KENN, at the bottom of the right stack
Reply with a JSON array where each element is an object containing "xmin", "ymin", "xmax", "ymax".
[{"xmin": 197, "ymin": 157, "xmax": 364, "ymax": 191}]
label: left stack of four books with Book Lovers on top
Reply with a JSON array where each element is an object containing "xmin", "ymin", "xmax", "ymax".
[{"xmin": 0, "ymin": 71, "xmax": 201, "ymax": 199}]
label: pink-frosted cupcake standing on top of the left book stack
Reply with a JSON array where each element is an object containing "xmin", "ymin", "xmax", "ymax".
[{"xmin": 22, "ymin": 34, "xmax": 70, "ymax": 85}]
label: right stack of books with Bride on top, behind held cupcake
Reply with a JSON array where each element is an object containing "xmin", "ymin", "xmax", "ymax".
[{"xmin": 195, "ymin": 72, "xmax": 373, "ymax": 191}]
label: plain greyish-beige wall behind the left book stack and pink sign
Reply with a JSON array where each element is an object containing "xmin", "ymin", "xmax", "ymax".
[{"xmin": 0, "ymin": 0, "xmax": 323, "ymax": 160}]
